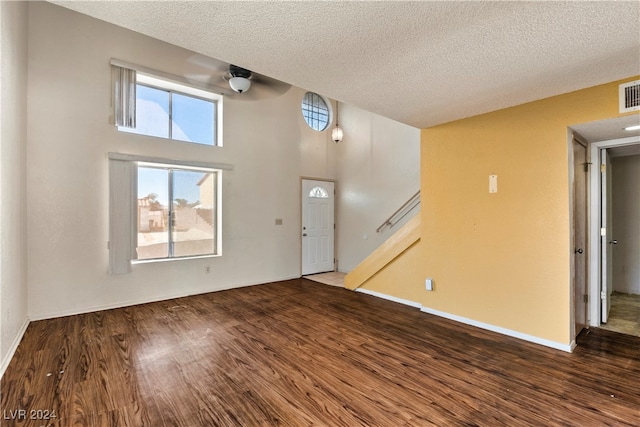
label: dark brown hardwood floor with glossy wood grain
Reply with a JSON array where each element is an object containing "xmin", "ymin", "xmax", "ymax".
[{"xmin": 0, "ymin": 279, "xmax": 640, "ymax": 427}]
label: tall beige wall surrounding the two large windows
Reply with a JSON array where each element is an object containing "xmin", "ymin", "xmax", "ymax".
[{"xmin": 23, "ymin": 2, "xmax": 336, "ymax": 319}]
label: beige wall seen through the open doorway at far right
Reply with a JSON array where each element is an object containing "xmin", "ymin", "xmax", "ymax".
[{"xmin": 611, "ymin": 155, "xmax": 640, "ymax": 294}]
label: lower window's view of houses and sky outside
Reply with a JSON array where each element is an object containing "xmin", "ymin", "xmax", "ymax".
[{"xmin": 136, "ymin": 163, "xmax": 220, "ymax": 260}]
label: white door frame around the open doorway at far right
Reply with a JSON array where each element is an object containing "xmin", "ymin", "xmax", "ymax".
[{"xmin": 588, "ymin": 136, "xmax": 640, "ymax": 327}]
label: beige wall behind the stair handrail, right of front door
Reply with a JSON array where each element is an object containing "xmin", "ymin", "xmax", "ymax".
[{"xmin": 334, "ymin": 104, "xmax": 420, "ymax": 272}]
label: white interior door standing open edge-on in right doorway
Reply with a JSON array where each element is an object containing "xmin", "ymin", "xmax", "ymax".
[{"xmin": 600, "ymin": 149, "xmax": 613, "ymax": 323}]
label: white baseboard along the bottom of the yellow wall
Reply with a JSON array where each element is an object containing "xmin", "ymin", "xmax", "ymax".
[{"xmin": 356, "ymin": 288, "xmax": 576, "ymax": 353}]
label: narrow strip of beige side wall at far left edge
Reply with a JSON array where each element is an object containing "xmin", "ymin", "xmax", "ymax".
[{"xmin": 0, "ymin": 2, "xmax": 27, "ymax": 375}]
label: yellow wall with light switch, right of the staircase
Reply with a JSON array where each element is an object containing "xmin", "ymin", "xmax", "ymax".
[{"xmin": 418, "ymin": 77, "xmax": 637, "ymax": 344}]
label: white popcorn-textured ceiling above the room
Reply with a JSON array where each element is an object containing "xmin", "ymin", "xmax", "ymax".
[{"xmin": 53, "ymin": 1, "xmax": 640, "ymax": 128}]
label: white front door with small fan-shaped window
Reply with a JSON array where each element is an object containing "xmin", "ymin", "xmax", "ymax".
[{"xmin": 301, "ymin": 179, "xmax": 335, "ymax": 276}]
